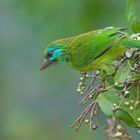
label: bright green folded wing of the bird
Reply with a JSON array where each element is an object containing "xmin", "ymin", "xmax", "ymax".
[{"xmin": 69, "ymin": 27, "xmax": 125, "ymax": 67}]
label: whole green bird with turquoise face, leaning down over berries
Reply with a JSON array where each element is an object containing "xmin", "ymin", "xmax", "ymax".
[{"xmin": 40, "ymin": 27, "xmax": 140, "ymax": 73}]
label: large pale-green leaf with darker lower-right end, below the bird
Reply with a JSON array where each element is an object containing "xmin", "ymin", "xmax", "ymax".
[{"xmin": 98, "ymin": 92, "xmax": 137, "ymax": 127}]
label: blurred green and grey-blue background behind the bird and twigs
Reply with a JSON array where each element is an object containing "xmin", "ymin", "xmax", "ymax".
[{"xmin": 0, "ymin": 0, "xmax": 139, "ymax": 140}]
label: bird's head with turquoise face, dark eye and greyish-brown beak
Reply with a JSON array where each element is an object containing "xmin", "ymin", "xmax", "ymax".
[{"xmin": 40, "ymin": 43, "xmax": 64, "ymax": 70}]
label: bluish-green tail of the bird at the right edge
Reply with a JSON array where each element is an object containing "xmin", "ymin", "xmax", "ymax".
[{"xmin": 120, "ymin": 34, "xmax": 140, "ymax": 49}]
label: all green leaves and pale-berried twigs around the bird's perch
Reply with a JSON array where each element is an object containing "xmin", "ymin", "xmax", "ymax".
[{"xmin": 72, "ymin": 0, "xmax": 140, "ymax": 140}]
